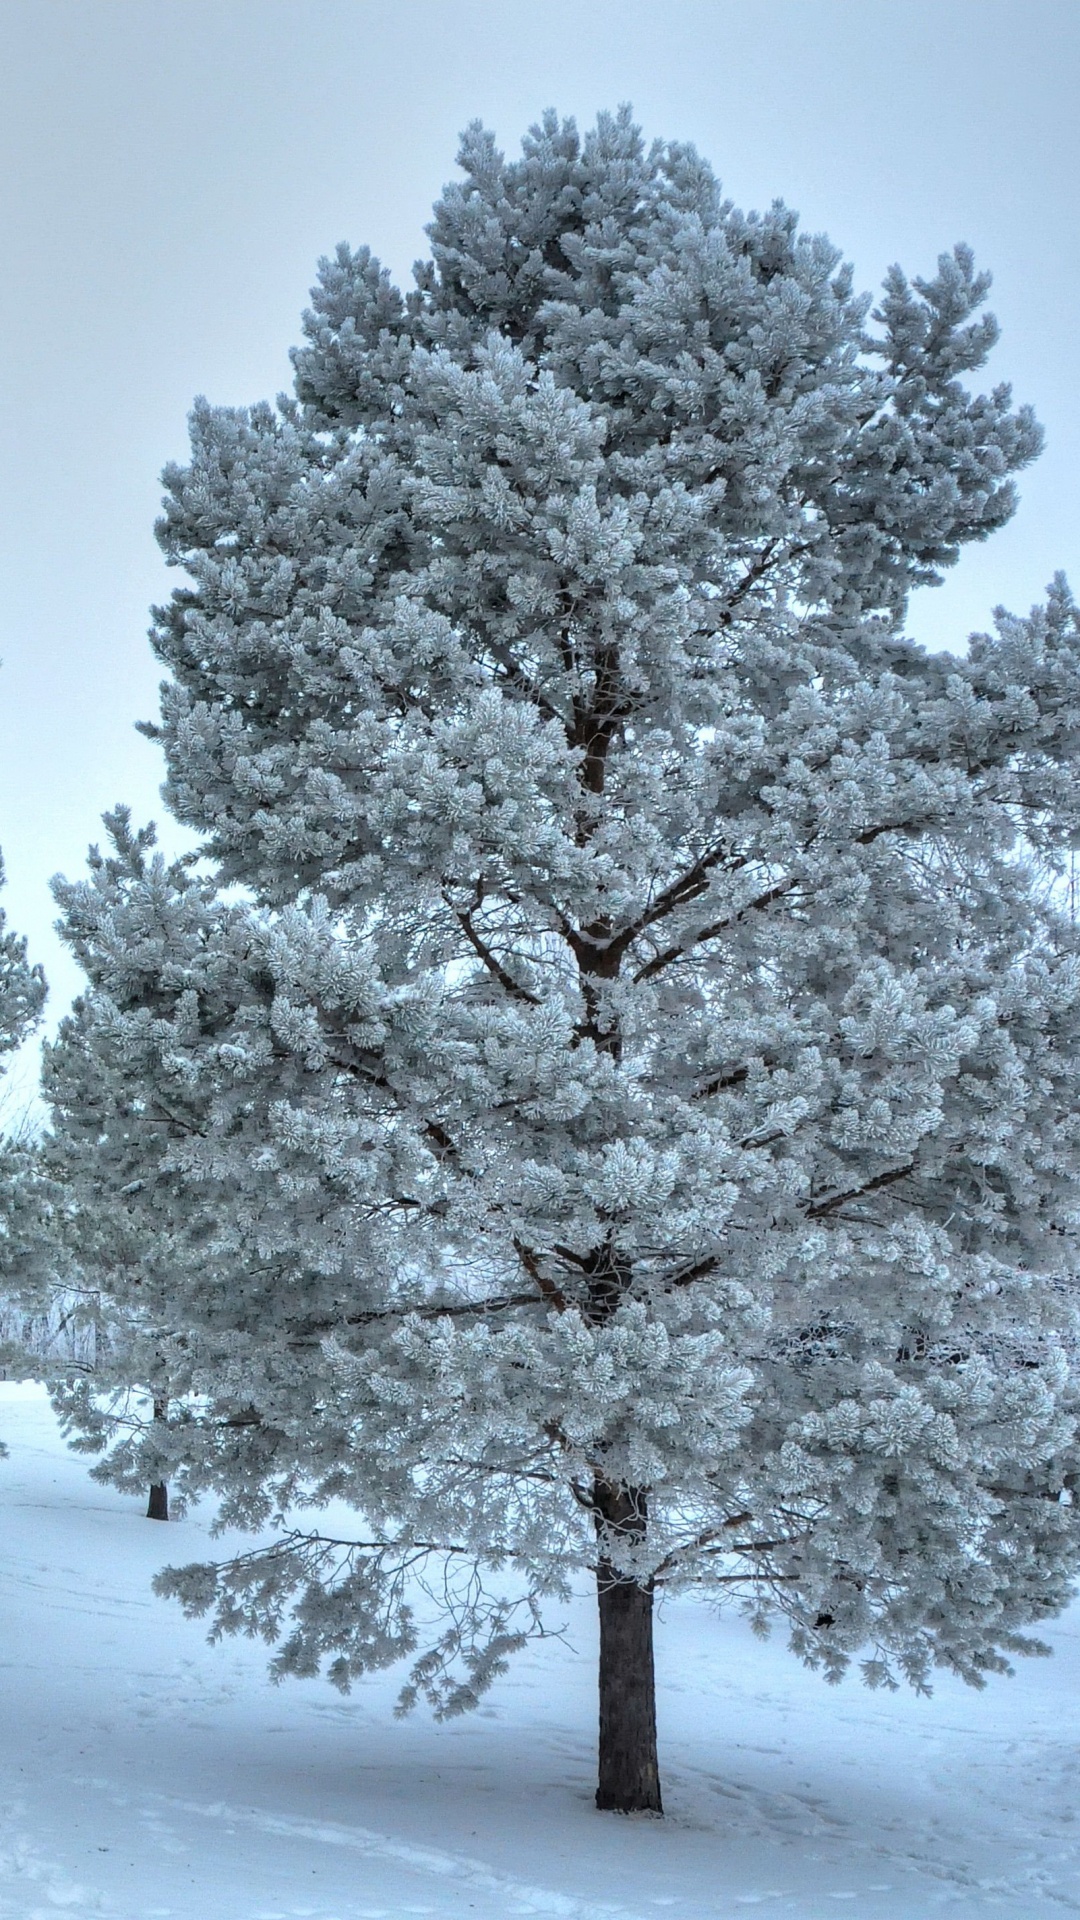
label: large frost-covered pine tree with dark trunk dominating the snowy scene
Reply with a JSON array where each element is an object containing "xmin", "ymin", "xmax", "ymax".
[{"xmin": 50, "ymin": 115, "xmax": 1080, "ymax": 1811}]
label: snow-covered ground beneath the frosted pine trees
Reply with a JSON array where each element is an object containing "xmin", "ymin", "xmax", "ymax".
[{"xmin": 0, "ymin": 1386, "xmax": 1080, "ymax": 1920}]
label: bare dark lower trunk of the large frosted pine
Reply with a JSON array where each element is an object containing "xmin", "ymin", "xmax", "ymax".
[{"xmin": 596, "ymin": 1482, "xmax": 663, "ymax": 1812}]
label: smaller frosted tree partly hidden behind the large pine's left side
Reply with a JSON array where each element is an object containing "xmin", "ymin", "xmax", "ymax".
[{"xmin": 40, "ymin": 806, "xmax": 228, "ymax": 1521}]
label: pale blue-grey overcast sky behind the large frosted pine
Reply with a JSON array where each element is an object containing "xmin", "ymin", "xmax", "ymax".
[{"xmin": 0, "ymin": 0, "xmax": 1080, "ymax": 1082}]
